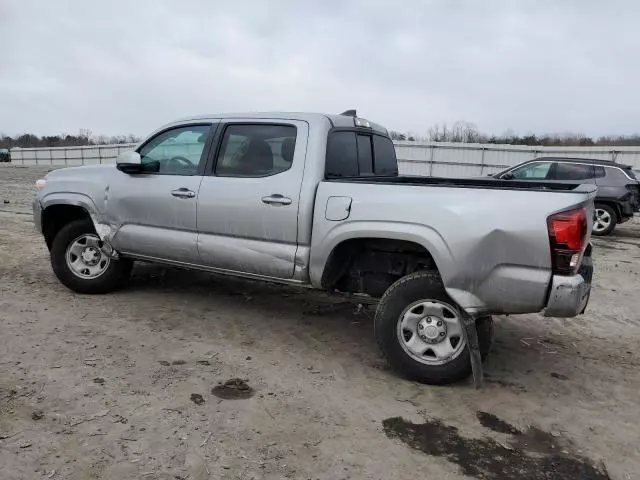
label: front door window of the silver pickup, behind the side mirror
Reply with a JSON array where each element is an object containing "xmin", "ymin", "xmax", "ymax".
[{"xmin": 139, "ymin": 125, "xmax": 211, "ymax": 175}]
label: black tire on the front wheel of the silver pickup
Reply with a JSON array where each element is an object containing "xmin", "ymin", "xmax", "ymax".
[{"xmin": 51, "ymin": 219, "xmax": 133, "ymax": 294}]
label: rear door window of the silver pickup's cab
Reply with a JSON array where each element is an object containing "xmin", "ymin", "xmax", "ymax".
[{"xmin": 215, "ymin": 123, "xmax": 297, "ymax": 177}]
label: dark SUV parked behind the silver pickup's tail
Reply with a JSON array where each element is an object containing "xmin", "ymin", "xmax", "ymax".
[{"xmin": 494, "ymin": 157, "xmax": 640, "ymax": 235}]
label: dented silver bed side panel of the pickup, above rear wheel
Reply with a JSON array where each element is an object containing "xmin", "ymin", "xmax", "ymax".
[{"xmin": 310, "ymin": 180, "xmax": 595, "ymax": 313}]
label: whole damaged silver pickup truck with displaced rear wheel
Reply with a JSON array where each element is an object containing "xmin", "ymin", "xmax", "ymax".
[{"xmin": 34, "ymin": 112, "xmax": 596, "ymax": 384}]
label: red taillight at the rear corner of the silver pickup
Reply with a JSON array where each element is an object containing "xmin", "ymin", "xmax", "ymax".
[{"xmin": 547, "ymin": 207, "xmax": 588, "ymax": 275}]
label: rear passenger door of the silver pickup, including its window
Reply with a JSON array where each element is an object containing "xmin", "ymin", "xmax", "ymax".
[{"xmin": 198, "ymin": 119, "xmax": 309, "ymax": 279}]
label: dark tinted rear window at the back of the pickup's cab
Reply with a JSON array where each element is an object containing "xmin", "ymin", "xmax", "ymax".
[{"xmin": 325, "ymin": 130, "xmax": 398, "ymax": 179}]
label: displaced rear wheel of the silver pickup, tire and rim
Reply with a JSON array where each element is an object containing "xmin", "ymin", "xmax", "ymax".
[{"xmin": 374, "ymin": 272, "xmax": 493, "ymax": 385}]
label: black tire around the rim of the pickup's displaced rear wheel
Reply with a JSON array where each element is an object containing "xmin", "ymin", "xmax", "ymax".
[{"xmin": 374, "ymin": 271, "xmax": 493, "ymax": 385}]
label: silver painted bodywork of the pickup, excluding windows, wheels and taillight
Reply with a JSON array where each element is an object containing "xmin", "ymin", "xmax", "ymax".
[{"xmin": 34, "ymin": 113, "xmax": 596, "ymax": 316}]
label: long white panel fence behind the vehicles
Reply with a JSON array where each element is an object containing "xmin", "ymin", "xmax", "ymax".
[{"xmin": 11, "ymin": 142, "xmax": 640, "ymax": 177}]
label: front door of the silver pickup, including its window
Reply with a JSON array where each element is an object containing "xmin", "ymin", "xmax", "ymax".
[{"xmin": 105, "ymin": 124, "xmax": 212, "ymax": 263}]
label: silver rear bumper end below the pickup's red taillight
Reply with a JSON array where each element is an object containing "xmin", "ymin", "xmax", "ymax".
[{"xmin": 544, "ymin": 246, "xmax": 593, "ymax": 317}]
